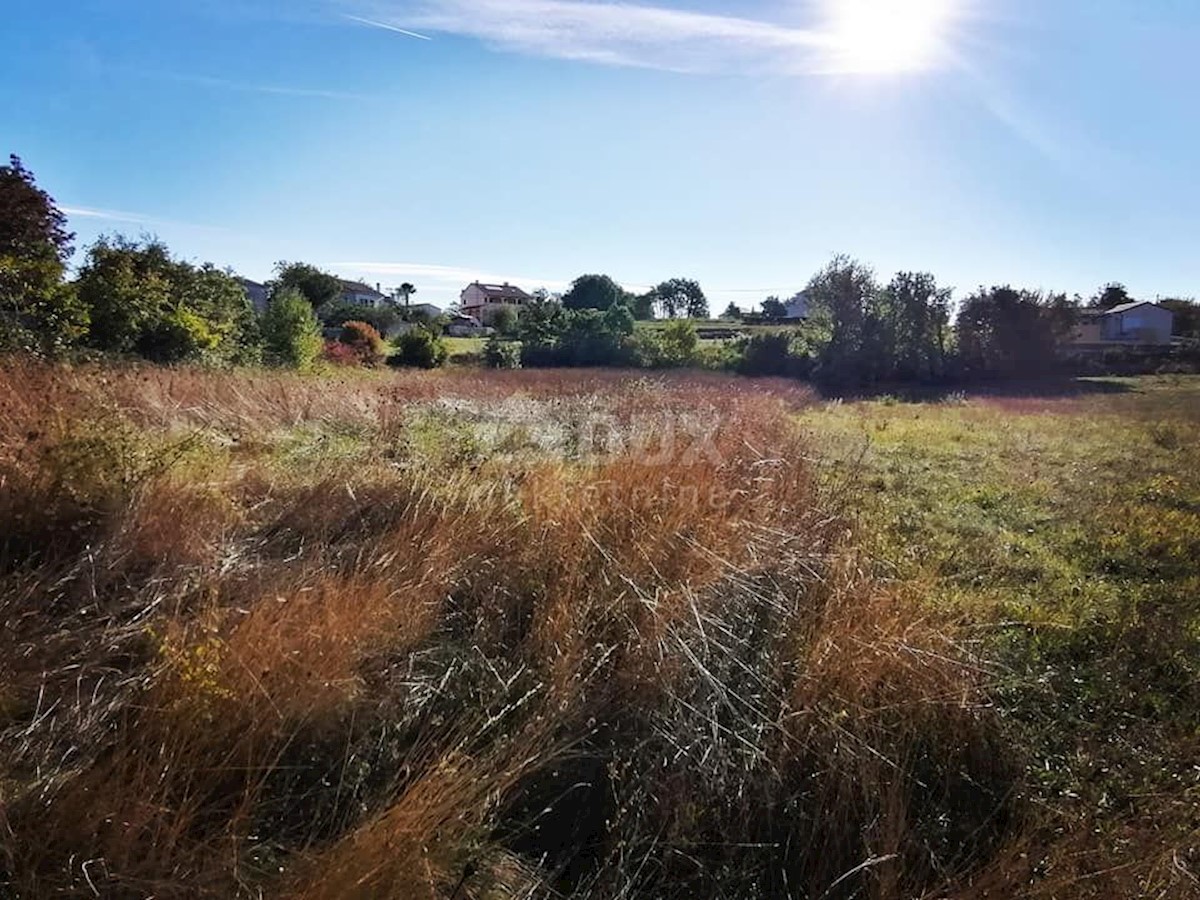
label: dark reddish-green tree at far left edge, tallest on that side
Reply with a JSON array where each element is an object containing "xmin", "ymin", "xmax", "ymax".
[{"xmin": 0, "ymin": 156, "xmax": 88, "ymax": 353}]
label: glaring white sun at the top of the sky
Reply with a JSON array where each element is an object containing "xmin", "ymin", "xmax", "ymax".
[{"xmin": 826, "ymin": 0, "xmax": 961, "ymax": 74}]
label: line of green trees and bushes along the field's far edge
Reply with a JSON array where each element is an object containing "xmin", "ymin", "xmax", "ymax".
[{"xmin": 0, "ymin": 156, "xmax": 1200, "ymax": 386}]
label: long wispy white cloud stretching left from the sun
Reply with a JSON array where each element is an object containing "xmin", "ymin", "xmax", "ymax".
[{"xmin": 336, "ymin": 0, "xmax": 835, "ymax": 73}]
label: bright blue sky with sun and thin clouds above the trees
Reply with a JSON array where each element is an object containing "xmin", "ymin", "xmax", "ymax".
[{"xmin": 0, "ymin": 0, "xmax": 1200, "ymax": 307}]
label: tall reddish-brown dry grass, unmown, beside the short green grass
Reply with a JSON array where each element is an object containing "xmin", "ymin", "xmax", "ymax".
[{"xmin": 0, "ymin": 362, "xmax": 1013, "ymax": 900}]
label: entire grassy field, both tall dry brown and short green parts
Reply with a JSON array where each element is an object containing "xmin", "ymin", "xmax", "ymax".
[{"xmin": 0, "ymin": 361, "xmax": 1200, "ymax": 900}]
